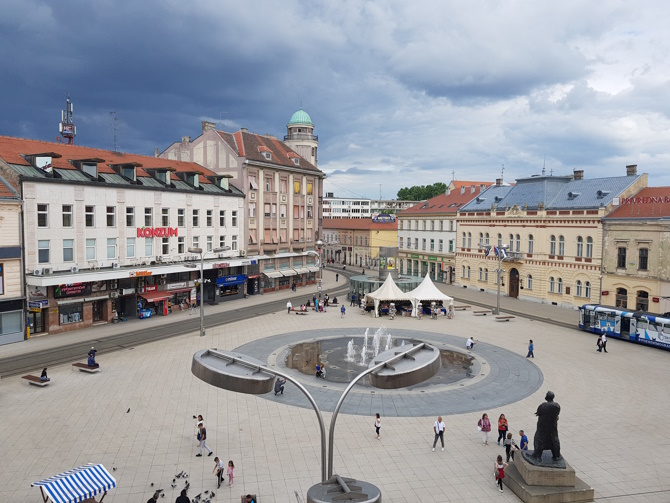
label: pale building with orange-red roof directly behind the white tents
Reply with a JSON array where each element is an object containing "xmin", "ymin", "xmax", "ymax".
[{"xmin": 398, "ymin": 181, "xmax": 492, "ymax": 283}]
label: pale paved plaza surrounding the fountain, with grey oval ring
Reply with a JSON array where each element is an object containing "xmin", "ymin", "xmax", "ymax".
[{"xmin": 0, "ymin": 272, "xmax": 670, "ymax": 503}]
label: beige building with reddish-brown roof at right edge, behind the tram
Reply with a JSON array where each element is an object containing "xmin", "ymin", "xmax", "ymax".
[{"xmin": 594, "ymin": 187, "xmax": 670, "ymax": 313}]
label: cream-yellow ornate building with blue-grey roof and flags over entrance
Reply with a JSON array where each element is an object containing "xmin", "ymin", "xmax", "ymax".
[{"xmin": 456, "ymin": 166, "xmax": 647, "ymax": 307}]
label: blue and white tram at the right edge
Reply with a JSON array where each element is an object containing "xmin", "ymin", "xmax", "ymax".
[{"xmin": 579, "ymin": 304, "xmax": 670, "ymax": 350}]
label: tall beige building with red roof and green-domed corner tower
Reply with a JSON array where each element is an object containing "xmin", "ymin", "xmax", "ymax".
[{"xmin": 160, "ymin": 111, "xmax": 325, "ymax": 292}]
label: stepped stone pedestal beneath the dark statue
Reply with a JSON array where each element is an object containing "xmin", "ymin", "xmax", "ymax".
[{"xmin": 503, "ymin": 451, "xmax": 594, "ymax": 503}]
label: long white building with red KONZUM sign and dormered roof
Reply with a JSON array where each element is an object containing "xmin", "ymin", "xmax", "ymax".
[{"xmin": 0, "ymin": 137, "xmax": 248, "ymax": 334}]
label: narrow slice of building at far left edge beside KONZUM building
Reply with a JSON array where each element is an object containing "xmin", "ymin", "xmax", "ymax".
[{"xmin": 0, "ymin": 176, "xmax": 26, "ymax": 345}]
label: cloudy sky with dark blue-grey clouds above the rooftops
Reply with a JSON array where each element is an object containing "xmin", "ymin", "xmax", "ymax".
[{"xmin": 0, "ymin": 0, "xmax": 670, "ymax": 198}]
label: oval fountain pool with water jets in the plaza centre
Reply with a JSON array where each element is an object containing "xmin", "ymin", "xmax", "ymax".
[{"xmin": 284, "ymin": 337, "xmax": 475, "ymax": 389}]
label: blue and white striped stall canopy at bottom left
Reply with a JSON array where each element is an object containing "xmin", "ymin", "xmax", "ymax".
[{"xmin": 31, "ymin": 463, "xmax": 116, "ymax": 503}]
